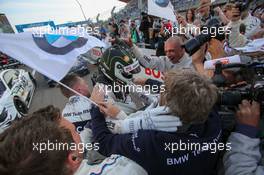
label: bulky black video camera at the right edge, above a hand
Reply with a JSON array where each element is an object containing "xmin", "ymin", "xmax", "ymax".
[{"xmin": 212, "ymin": 61, "xmax": 264, "ymax": 111}]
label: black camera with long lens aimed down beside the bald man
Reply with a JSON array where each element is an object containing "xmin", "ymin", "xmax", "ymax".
[{"xmin": 182, "ymin": 18, "xmax": 225, "ymax": 56}]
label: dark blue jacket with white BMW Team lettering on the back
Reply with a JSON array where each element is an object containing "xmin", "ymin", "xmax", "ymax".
[{"xmin": 91, "ymin": 107, "xmax": 222, "ymax": 175}]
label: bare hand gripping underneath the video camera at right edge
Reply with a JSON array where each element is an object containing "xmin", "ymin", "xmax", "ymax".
[{"xmin": 236, "ymin": 100, "xmax": 260, "ymax": 128}]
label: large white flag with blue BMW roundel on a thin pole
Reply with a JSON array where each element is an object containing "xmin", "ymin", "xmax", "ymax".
[{"xmin": 0, "ymin": 33, "xmax": 105, "ymax": 81}]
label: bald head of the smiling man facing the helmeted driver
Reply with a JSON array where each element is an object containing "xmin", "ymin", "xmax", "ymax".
[{"xmin": 164, "ymin": 36, "xmax": 185, "ymax": 64}]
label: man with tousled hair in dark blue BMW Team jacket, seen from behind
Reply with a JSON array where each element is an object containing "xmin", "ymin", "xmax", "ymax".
[{"xmin": 91, "ymin": 69, "xmax": 222, "ymax": 175}]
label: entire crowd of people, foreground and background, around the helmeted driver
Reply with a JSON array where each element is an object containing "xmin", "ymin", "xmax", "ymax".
[{"xmin": 0, "ymin": 0, "xmax": 264, "ymax": 175}]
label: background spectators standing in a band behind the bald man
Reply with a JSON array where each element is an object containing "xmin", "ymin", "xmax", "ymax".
[{"xmin": 98, "ymin": 1, "xmax": 264, "ymax": 53}]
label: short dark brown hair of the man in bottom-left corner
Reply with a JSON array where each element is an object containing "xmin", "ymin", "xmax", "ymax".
[{"xmin": 0, "ymin": 106, "xmax": 74, "ymax": 175}]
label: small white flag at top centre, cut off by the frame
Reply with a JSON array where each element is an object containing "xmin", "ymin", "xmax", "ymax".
[{"xmin": 148, "ymin": 0, "xmax": 176, "ymax": 22}]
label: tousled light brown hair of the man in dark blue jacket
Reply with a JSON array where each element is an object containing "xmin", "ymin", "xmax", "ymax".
[{"xmin": 164, "ymin": 69, "xmax": 217, "ymax": 124}]
